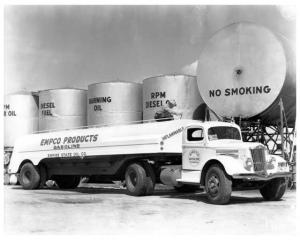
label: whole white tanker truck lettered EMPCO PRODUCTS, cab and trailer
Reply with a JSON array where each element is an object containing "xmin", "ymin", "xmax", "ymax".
[{"xmin": 8, "ymin": 120, "xmax": 290, "ymax": 204}]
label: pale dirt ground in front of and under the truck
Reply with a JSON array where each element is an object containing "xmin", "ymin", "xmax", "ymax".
[{"xmin": 4, "ymin": 184, "xmax": 296, "ymax": 236}]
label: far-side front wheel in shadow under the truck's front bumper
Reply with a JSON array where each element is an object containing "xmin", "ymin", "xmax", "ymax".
[{"xmin": 259, "ymin": 178, "xmax": 287, "ymax": 201}]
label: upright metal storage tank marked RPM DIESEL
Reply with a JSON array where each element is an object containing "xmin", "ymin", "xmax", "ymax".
[{"xmin": 143, "ymin": 74, "xmax": 206, "ymax": 121}]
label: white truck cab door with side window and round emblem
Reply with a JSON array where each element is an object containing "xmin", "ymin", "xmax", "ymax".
[{"xmin": 182, "ymin": 126, "xmax": 204, "ymax": 170}]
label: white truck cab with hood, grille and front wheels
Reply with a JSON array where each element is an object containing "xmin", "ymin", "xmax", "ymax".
[{"xmin": 177, "ymin": 122, "xmax": 290, "ymax": 204}]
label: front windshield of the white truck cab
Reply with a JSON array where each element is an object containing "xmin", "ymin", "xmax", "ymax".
[{"xmin": 208, "ymin": 126, "xmax": 241, "ymax": 141}]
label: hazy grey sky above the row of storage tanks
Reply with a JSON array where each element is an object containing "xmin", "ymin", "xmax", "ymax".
[{"xmin": 4, "ymin": 5, "xmax": 296, "ymax": 93}]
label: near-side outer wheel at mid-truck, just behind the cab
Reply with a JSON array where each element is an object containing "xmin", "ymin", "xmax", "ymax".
[{"xmin": 125, "ymin": 163, "xmax": 151, "ymax": 196}]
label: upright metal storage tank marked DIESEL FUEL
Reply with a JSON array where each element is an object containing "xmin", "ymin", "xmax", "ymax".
[{"xmin": 39, "ymin": 88, "xmax": 87, "ymax": 131}]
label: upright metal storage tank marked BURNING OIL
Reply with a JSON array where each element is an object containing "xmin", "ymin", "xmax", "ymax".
[{"xmin": 88, "ymin": 81, "xmax": 142, "ymax": 126}]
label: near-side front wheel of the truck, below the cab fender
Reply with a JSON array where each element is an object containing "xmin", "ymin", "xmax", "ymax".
[{"xmin": 205, "ymin": 164, "xmax": 232, "ymax": 204}]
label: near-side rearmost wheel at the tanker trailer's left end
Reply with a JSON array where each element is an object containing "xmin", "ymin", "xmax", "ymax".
[{"xmin": 19, "ymin": 163, "xmax": 40, "ymax": 189}]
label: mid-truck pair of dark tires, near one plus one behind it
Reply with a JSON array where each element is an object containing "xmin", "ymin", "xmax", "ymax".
[{"xmin": 125, "ymin": 163, "xmax": 155, "ymax": 196}]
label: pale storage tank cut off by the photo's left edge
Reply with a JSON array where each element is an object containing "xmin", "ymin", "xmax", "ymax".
[{"xmin": 4, "ymin": 92, "xmax": 38, "ymax": 147}]
